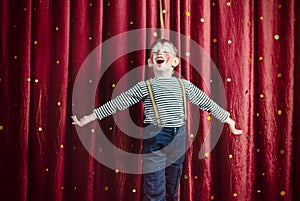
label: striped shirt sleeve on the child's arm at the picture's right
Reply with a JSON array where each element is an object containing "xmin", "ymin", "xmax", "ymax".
[{"xmin": 184, "ymin": 80, "xmax": 230, "ymax": 123}]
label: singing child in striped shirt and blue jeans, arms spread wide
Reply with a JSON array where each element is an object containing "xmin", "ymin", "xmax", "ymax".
[{"xmin": 72, "ymin": 39, "xmax": 242, "ymax": 201}]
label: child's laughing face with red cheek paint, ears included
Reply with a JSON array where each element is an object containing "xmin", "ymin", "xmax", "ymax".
[{"xmin": 148, "ymin": 42, "xmax": 179, "ymax": 73}]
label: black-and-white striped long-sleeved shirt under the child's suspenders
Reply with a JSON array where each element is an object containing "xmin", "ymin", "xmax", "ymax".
[{"xmin": 93, "ymin": 77, "xmax": 229, "ymax": 127}]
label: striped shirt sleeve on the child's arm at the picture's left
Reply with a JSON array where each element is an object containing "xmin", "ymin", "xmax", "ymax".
[{"xmin": 93, "ymin": 81, "xmax": 147, "ymax": 119}]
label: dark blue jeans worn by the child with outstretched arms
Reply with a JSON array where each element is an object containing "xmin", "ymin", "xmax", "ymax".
[{"xmin": 142, "ymin": 125, "xmax": 186, "ymax": 201}]
